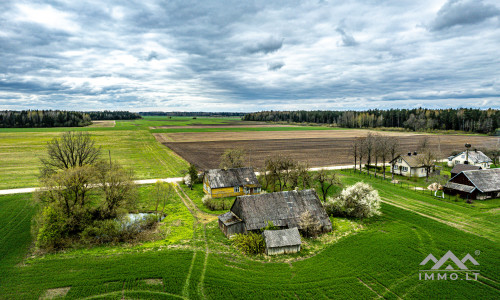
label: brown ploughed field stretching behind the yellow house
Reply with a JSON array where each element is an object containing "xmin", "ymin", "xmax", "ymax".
[{"xmin": 154, "ymin": 127, "xmax": 500, "ymax": 169}]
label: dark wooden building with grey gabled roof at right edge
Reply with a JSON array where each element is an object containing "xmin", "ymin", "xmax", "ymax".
[{"xmin": 444, "ymin": 169, "xmax": 500, "ymax": 200}]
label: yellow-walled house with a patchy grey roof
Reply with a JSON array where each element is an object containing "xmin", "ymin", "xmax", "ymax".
[{"xmin": 203, "ymin": 168, "xmax": 260, "ymax": 198}]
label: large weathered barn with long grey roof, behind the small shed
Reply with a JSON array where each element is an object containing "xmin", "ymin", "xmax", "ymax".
[{"xmin": 219, "ymin": 189, "xmax": 332, "ymax": 237}]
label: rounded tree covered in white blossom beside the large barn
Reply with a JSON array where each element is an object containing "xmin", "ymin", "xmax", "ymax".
[{"xmin": 326, "ymin": 182, "xmax": 380, "ymax": 218}]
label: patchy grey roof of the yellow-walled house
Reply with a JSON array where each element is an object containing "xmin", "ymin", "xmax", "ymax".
[{"xmin": 205, "ymin": 168, "xmax": 260, "ymax": 189}]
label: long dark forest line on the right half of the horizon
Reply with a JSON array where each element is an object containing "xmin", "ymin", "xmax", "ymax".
[{"xmin": 243, "ymin": 108, "xmax": 500, "ymax": 134}]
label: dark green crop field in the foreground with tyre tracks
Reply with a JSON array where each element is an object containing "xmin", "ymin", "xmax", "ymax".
[{"xmin": 0, "ymin": 182, "xmax": 500, "ymax": 299}]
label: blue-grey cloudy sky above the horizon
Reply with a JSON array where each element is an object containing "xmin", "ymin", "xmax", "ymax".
[{"xmin": 0, "ymin": 0, "xmax": 500, "ymax": 111}]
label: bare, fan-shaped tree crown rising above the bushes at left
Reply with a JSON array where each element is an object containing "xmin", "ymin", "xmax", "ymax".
[{"xmin": 41, "ymin": 131, "xmax": 101, "ymax": 176}]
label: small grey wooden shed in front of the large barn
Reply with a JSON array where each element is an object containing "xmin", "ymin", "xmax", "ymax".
[{"xmin": 262, "ymin": 227, "xmax": 302, "ymax": 255}]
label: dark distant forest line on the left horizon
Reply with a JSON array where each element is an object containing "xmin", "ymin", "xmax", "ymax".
[{"xmin": 0, "ymin": 110, "xmax": 141, "ymax": 128}]
